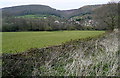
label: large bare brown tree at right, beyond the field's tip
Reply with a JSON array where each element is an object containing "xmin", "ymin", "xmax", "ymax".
[{"xmin": 94, "ymin": 2, "xmax": 118, "ymax": 30}]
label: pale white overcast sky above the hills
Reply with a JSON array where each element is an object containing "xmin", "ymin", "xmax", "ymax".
[{"xmin": 0, "ymin": 0, "xmax": 118, "ymax": 10}]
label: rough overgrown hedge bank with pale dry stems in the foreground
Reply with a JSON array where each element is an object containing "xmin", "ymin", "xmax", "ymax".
[{"xmin": 2, "ymin": 32, "xmax": 120, "ymax": 77}]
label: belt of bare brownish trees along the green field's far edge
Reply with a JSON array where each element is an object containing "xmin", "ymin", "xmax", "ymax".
[{"xmin": 2, "ymin": 17, "xmax": 100, "ymax": 32}]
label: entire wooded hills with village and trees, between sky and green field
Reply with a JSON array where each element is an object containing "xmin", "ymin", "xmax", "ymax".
[{"xmin": 2, "ymin": 3, "xmax": 118, "ymax": 32}]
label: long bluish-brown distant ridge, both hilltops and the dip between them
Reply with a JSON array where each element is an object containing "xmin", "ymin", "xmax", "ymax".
[{"xmin": 2, "ymin": 5, "xmax": 101, "ymax": 18}]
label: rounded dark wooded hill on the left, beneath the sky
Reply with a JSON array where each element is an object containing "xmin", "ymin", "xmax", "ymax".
[{"xmin": 2, "ymin": 5, "xmax": 61, "ymax": 16}]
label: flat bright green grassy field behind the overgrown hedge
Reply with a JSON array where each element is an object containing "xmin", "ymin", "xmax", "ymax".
[{"xmin": 2, "ymin": 31, "xmax": 105, "ymax": 53}]
